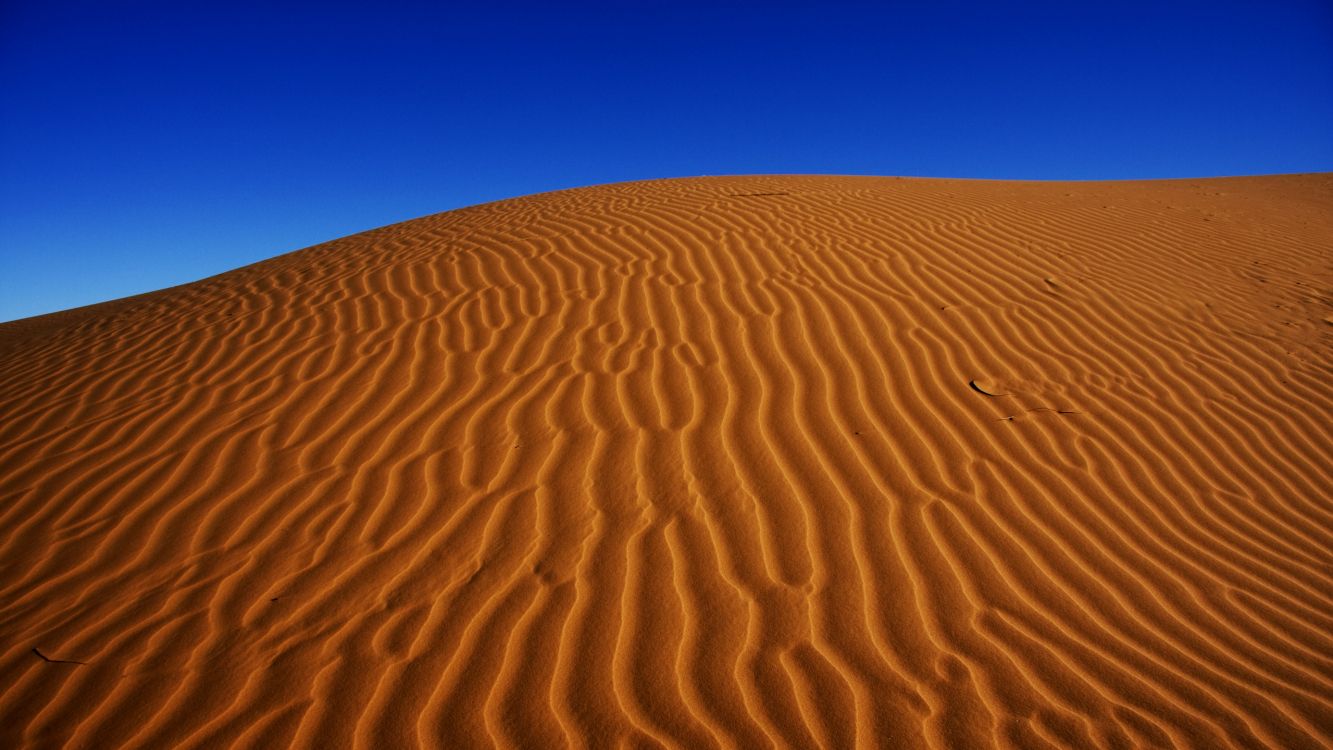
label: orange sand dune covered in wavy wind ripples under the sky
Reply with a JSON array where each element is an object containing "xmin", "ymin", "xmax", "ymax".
[{"xmin": 0, "ymin": 175, "xmax": 1333, "ymax": 749}]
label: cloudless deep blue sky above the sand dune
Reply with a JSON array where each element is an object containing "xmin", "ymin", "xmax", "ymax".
[{"xmin": 0, "ymin": 0, "xmax": 1333, "ymax": 320}]
